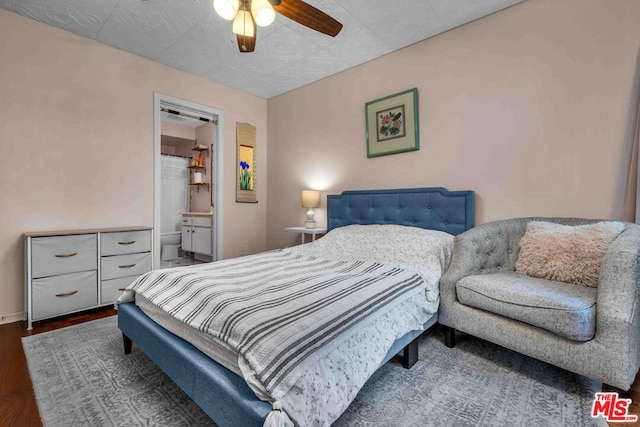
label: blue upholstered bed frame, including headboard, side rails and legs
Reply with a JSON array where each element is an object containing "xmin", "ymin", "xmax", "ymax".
[{"xmin": 118, "ymin": 187, "xmax": 475, "ymax": 427}]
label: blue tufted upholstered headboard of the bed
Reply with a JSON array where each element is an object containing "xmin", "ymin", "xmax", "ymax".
[{"xmin": 327, "ymin": 187, "xmax": 475, "ymax": 235}]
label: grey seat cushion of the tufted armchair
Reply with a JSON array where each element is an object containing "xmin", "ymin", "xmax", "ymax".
[{"xmin": 456, "ymin": 271, "xmax": 597, "ymax": 341}]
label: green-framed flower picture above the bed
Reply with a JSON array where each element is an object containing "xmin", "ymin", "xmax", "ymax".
[{"xmin": 364, "ymin": 88, "xmax": 420, "ymax": 157}]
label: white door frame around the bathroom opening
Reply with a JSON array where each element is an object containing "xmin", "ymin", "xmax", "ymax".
[{"xmin": 153, "ymin": 92, "xmax": 224, "ymax": 269}]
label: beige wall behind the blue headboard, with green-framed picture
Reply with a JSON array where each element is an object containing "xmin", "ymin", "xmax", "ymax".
[{"xmin": 268, "ymin": 0, "xmax": 640, "ymax": 248}]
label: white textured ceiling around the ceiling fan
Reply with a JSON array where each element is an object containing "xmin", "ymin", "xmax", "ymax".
[{"xmin": 0, "ymin": 0, "xmax": 522, "ymax": 98}]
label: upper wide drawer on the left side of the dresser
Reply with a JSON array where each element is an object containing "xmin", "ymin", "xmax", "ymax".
[{"xmin": 31, "ymin": 234, "xmax": 98, "ymax": 278}]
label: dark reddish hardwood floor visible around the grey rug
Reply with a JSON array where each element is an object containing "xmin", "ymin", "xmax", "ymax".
[{"xmin": 0, "ymin": 307, "xmax": 640, "ymax": 427}]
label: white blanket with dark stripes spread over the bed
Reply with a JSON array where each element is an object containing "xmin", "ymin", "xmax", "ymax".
[{"xmin": 122, "ymin": 250, "xmax": 426, "ymax": 400}]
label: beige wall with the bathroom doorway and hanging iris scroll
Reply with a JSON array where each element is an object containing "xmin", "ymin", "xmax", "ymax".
[{"xmin": 0, "ymin": 9, "xmax": 267, "ymax": 322}]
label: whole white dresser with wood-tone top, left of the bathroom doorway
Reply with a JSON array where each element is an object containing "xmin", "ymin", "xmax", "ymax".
[{"xmin": 24, "ymin": 227, "xmax": 152, "ymax": 330}]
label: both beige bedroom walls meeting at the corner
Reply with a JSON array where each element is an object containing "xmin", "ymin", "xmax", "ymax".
[{"xmin": 0, "ymin": 0, "xmax": 640, "ymax": 322}]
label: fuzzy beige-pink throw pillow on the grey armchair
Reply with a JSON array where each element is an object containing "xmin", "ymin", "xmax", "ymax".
[{"xmin": 516, "ymin": 221, "xmax": 624, "ymax": 287}]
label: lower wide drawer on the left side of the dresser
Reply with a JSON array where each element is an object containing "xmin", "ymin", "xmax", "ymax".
[{"xmin": 32, "ymin": 271, "xmax": 98, "ymax": 320}]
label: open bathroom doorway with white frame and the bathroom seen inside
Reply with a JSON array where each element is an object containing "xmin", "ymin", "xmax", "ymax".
[{"xmin": 153, "ymin": 93, "xmax": 224, "ymax": 269}]
